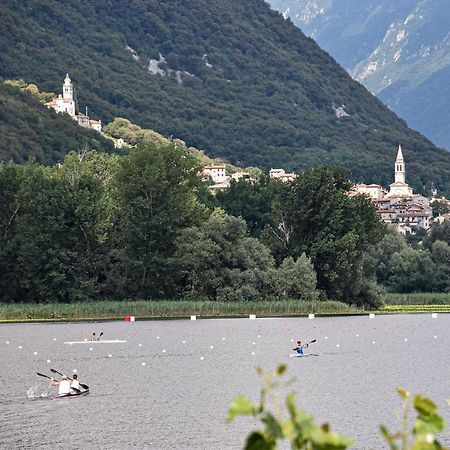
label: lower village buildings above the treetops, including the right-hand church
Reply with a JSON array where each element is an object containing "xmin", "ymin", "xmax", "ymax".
[{"xmin": 205, "ymin": 145, "xmax": 450, "ymax": 234}]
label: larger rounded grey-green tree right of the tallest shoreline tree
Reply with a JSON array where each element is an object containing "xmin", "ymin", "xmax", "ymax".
[{"xmin": 174, "ymin": 210, "xmax": 274, "ymax": 300}]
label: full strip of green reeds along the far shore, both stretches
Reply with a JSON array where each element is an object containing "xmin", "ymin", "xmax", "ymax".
[{"xmin": 0, "ymin": 293, "xmax": 450, "ymax": 322}]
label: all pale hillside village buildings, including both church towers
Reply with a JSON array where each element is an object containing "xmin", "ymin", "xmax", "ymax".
[{"xmin": 45, "ymin": 73, "xmax": 450, "ymax": 234}]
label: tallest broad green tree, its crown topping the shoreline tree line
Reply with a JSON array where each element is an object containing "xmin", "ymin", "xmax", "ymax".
[{"xmin": 114, "ymin": 144, "xmax": 207, "ymax": 298}]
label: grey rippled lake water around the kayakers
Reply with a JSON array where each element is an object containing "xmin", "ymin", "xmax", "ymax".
[{"xmin": 0, "ymin": 314, "xmax": 450, "ymax": 450}]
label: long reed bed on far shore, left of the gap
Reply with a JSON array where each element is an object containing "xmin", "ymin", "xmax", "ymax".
[{"xmin": 0, "ymin": 300, "xmax": 352, "ymax": 321}]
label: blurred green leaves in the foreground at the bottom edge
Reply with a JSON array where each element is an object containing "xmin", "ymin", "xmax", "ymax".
[{"xmin": 227, "ymin": 365, "xmax": 446, "ymax": 450}]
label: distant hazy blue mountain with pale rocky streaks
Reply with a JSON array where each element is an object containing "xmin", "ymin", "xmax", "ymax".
[{"xmin": 270, "ymin": 0, "xmax": 450, "ymax": 150}]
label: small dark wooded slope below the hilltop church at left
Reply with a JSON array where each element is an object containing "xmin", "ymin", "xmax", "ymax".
[{"xmin": 0, "ymin": 82, "xmax": 114, "ymax": 164}]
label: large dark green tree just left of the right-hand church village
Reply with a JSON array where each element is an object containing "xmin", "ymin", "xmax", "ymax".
[{"xmin": 272, "ymin": 167, "xmax": 384, "ymax": 303}]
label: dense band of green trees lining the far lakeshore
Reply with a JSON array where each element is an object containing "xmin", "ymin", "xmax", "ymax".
[{"xmin": 0, "ymin": 143, "xmax": 450, "ymax": 307}]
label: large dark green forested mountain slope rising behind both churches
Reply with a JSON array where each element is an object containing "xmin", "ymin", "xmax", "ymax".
[{"xmin": 0, "ymin": 0, "xmax": 450, "ymax": 192}]
